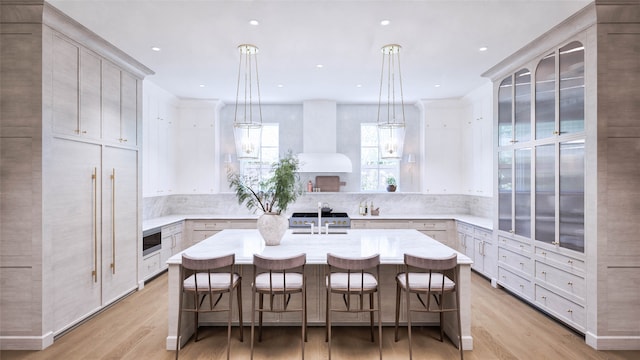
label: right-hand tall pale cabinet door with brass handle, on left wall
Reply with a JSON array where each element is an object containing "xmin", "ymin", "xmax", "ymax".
[{"xmin": 102, "ymin": 147, "xmax": 139, "ymax": 304}]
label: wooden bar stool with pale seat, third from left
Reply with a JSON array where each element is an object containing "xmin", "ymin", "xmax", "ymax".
[{"xmin": 325, "ymin": 254, "xmax": 382, "ymax": 359}]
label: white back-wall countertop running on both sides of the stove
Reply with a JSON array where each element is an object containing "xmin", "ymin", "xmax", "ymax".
[{"xmin": 142, "ymin": 214, "xmax": 493, "ymax": 231}]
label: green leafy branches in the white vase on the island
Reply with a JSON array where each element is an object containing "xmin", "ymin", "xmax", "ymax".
[{"xmin": 227, "ymin": 151, "xmax": 303, "ymax": 213}]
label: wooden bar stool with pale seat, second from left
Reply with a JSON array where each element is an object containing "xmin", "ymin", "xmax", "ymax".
[{"xmin": 251, "ymin": 254, "xmax": 307, "ymax": 359}]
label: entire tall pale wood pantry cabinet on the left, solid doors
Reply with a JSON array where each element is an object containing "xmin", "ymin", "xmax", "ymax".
[{"xmin": 0, "ymin": 1, "xmax": 152, "ymax": 349}]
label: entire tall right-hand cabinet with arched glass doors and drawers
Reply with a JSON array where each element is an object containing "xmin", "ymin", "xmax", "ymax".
[{"xmin": 484, "ymin": 0, "xmax": 640, "ymax": 350}]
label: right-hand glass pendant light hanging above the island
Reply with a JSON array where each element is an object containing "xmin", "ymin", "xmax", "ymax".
[{"xmin": 378, "ymin": 44, "xmax": 405, "ymax": 160}]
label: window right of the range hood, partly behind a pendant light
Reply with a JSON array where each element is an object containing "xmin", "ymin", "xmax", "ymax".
[{"xmin": 360, "ymin": 123, "xmax": 400, "ymax": 191}]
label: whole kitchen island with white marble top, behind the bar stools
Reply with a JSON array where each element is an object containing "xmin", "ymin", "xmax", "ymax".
[{"xmin": 166, "ymin": 229, "xmax": 473, "ymax": 350}]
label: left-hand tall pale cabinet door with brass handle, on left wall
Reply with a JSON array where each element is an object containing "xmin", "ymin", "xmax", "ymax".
[{"xmin": 50, "ymin": 139, "xmax": 102, "ymax": 333}]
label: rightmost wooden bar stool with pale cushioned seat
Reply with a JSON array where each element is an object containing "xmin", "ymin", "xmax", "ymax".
[{"xmin": 395, "ymin": 253, "xmax": 464, "ymax": 359}]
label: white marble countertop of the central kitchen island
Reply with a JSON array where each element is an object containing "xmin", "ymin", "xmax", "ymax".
[{"xmin": 167, "ymin": 229, "xmax": 473, "ymax": 265}]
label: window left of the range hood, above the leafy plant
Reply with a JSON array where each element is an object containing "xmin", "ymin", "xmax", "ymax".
[{"xmin": 240, "ymin": 124, "xmax": 280, "ymax": 183}]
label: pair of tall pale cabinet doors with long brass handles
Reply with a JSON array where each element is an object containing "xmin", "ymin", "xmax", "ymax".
[{"xmin": 46, "ymin": 139, "xmax": 139, "ymax": 333}]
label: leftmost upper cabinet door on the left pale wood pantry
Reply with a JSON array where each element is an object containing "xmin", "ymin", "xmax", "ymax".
[{"xmin": 51, "ymin": 35, "xmax": 80, "ymax": 135}]
